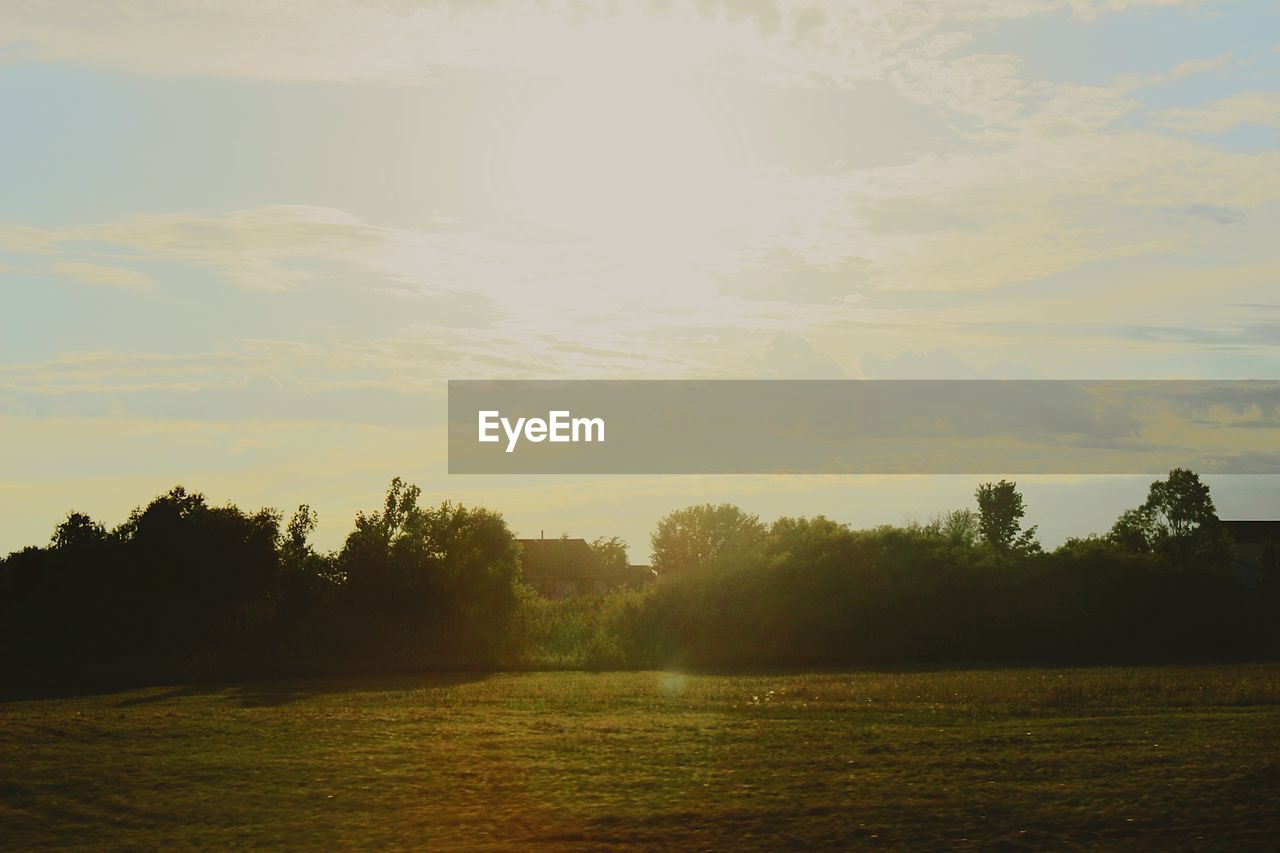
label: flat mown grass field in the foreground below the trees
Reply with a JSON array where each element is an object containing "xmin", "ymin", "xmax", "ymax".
[{"xmin": 0, "ymin": 665, "xmax": 1280, "ymax": 849}]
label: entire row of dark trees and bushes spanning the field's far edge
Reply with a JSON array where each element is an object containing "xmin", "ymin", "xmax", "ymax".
[{"xmin": 0, "ymin": 470, "xmax": 1280, "ymax": 684}]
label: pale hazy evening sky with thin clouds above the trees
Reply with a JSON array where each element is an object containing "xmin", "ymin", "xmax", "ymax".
[{"xmin": 0, "ymin": 0, "xmax": 1280, "ymax": 561}]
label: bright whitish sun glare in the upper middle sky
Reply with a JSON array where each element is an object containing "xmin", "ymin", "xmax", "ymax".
[{"xmin": 485, "ymin": 67, "xmax": 744, "ymax": 238}]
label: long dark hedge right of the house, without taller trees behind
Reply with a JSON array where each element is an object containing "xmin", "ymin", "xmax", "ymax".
[{"xmin": 605, "ymin": 517, "xmax": 1280, "ymax": 667}]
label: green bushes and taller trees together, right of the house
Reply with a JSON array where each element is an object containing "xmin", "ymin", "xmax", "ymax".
[{"xmin": 527, "ymin": 470, "xmax": 1280, "ymax": 667}]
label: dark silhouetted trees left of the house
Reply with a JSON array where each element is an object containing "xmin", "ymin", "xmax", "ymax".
[{"xmin": 0, "ymin": 479, "xmax": 522, "ymax": 683}]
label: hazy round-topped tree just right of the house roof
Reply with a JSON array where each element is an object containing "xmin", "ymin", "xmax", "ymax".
[{"xmin": 650, "ymin": 503, "xmax": 764, "ymax": 575}]
